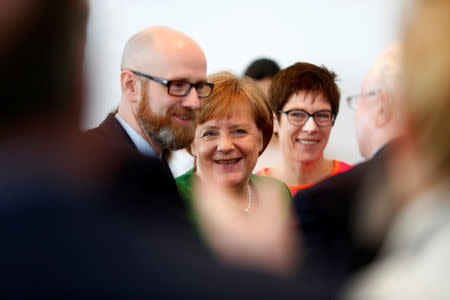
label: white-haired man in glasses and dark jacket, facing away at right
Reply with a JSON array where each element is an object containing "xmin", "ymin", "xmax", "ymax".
[{"xmin": 294, "ymin": 44, "xmax": 401, "ymax": 292}]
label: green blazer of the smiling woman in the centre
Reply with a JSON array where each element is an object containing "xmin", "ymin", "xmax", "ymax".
[{"xmin": 175, "ymin": 169, "xmax": 292, "ymax": 224}]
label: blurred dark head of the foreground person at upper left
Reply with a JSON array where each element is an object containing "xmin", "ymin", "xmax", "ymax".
[{"xmin": 0, "ymin": 0, "xmax": 88, "ymax": 135}]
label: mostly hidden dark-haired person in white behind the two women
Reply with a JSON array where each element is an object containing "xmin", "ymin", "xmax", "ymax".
[{"xmin": 244, "ymin": 58, "xmax": 281, "ymax": 170}]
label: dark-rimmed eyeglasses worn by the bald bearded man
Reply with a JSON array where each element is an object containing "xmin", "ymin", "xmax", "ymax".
[{"xmin": 130, "ymin": 70, "xmax": 214, "ymax": 98}]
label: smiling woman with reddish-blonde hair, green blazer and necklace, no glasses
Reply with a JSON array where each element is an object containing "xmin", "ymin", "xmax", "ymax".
[{"xmin": 176, "ymin": 72, "xmax": 292, "ymax": 220}]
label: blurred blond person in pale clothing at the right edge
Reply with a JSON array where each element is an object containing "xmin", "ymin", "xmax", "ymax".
[{"xmin": 346, "ymin": 0, "xmax": 450, "ymax": 300}]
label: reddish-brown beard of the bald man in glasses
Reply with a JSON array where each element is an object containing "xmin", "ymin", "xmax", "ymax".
[{"xmin": 137, "ymin": 89, "xmax": 197, "ymax": 150}]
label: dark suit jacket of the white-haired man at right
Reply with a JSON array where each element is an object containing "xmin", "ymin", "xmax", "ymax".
[{"xmin": 293, "ymin": 142, "xmax": 392, "ymax": 286}]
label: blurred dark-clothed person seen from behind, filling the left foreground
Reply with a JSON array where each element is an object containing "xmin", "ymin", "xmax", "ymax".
[{"xmin": 0, "ymin": 0, "xmax": 206, "ymax": 299}]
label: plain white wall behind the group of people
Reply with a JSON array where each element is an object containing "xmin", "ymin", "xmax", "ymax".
[{"xmin": 83, "ymin": 0, "xmax": 409, "ymax": 163}]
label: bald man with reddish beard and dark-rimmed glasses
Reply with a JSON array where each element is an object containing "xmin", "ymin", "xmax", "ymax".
[{"xmin": 88, "ymin": 26, "xmax": 214, "ymax": 158}]
